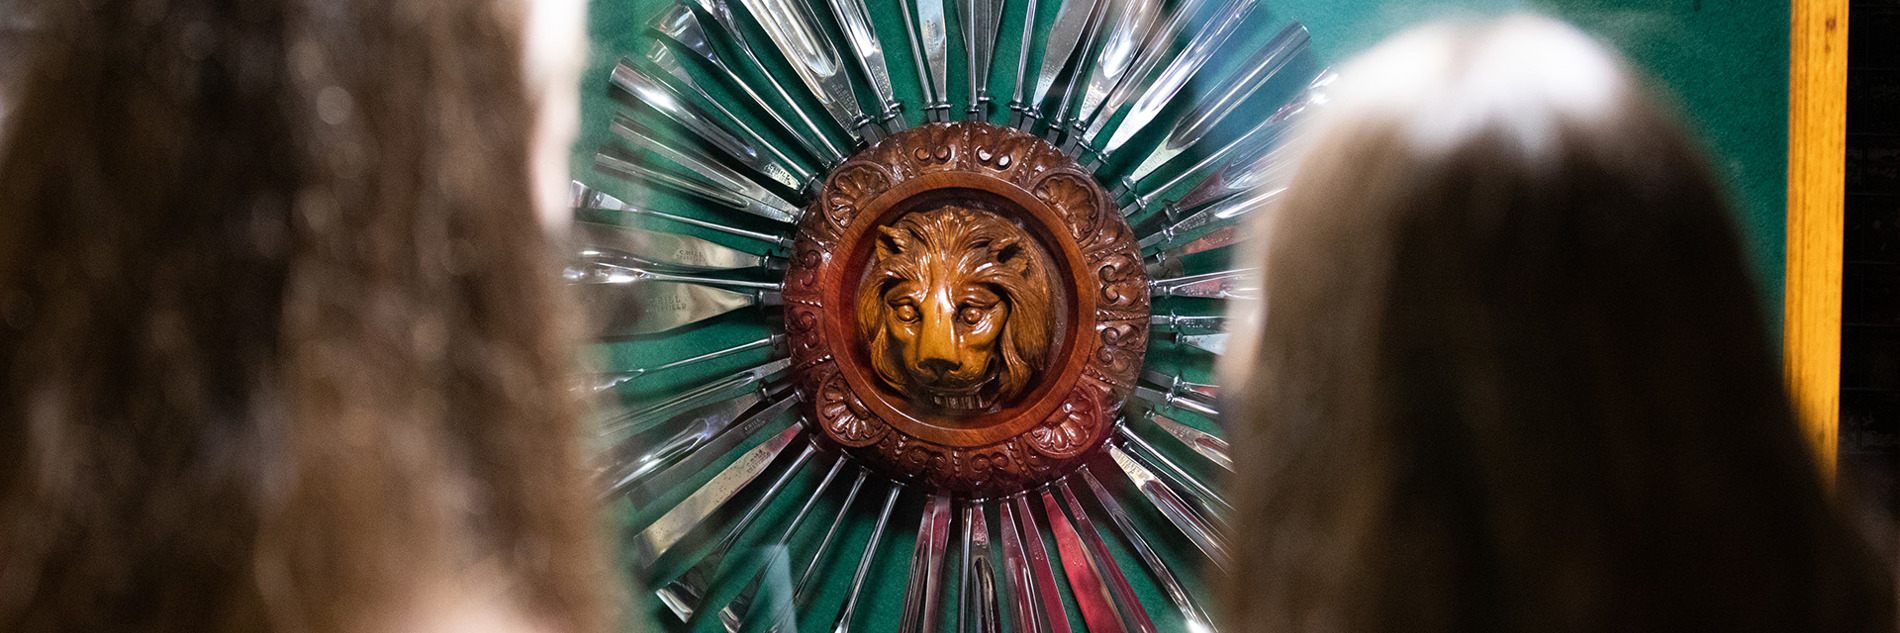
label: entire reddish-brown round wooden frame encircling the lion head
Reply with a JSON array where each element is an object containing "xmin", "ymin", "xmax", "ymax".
[{"xmin": 785, "ymin": 122, "xmax": 1150, "ymax": 496}]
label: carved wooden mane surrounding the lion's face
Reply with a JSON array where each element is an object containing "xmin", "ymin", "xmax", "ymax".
[{"xmin": 857, "ymin": 207, "xmax": 1055, "ymax": 399}]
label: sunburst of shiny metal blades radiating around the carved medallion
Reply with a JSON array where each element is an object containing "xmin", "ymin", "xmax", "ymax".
[{"xmin": 564, "ymin": 0, "xmax": 1330, "ymax": 633}]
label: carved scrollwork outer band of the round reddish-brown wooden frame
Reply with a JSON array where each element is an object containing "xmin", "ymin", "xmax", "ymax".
[{"xmin": 785, "ymin": 122, "xmax": 1150, "ymax": 496}]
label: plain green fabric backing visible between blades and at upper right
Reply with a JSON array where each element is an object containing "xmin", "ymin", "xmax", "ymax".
[{"xmin": 572, "ymin": 0, "xmax": 1788, "ymax": 631}]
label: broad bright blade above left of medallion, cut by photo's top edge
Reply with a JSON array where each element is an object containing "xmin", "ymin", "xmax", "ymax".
[{"xmin": 739, "ymin": 0, "xmax": 882, "ymax": 143}]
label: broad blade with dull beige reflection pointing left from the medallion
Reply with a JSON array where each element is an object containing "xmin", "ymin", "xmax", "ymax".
[{"xmin": 568, "ymin": 273, "xmax": 766, "ymax": 336}]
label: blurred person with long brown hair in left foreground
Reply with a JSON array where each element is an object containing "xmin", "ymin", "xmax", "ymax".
[{"xmin": 0, "ymin": 0, "xmax": 614, "ymax": 631}]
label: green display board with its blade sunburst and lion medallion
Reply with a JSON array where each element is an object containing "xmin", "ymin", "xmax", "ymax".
[{"xmin": 568, "ymin": 0, "xmax": 1786, "ymax": 631}]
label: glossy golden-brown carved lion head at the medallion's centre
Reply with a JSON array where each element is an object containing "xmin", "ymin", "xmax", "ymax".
[{"xmin": 857, "ymin": 207, "xmax": 1055, "ymax": 411}]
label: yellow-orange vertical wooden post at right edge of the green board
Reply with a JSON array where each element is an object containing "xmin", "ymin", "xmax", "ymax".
[{"xmin": 1782, "ymin": 0, "xmax": 1847, "ymax": 480}]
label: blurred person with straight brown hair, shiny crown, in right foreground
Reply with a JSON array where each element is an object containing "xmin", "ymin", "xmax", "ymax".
[{"xmin": 1222, "ymin": 17, "xmax": 1891, "ymax": 633}]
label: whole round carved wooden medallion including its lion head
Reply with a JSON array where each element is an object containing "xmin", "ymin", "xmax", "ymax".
[{"xmin": 785, "ymin": 122, "xmax": 1150, "ymax": 496}]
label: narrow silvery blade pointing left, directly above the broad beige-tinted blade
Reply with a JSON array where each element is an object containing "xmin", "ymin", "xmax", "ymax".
[{"xmin": 570, "ymin": 221, "xmax": 779, "ymax": 272}]
